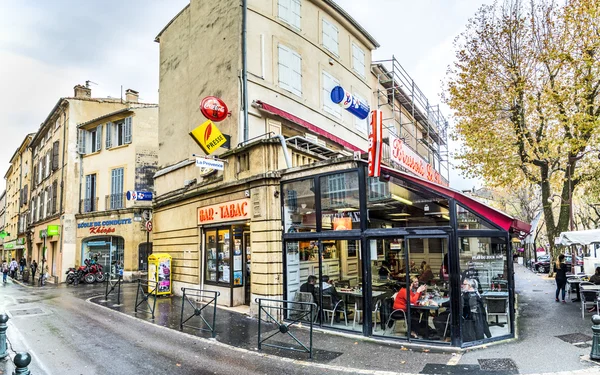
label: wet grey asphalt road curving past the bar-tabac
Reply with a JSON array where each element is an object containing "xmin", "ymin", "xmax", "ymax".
[{"xmin": 0, "ymin": 283, "xmax": 380, "ymax": 375}]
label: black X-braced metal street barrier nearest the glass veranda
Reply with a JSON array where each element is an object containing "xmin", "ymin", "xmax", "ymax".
[{"xmin": 255, "ymin": 298, "xmax": 317, "ymax": 359}]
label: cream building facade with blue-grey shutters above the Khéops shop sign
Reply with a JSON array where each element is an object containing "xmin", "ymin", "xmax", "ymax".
[{"xmin": 75, "ymin": 94, "xmax": 158, "ymax": 279}]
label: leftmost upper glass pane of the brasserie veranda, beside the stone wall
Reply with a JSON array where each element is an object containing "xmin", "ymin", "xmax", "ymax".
[{"xmin": 282, "ymin": 178, "xmax": 317, "ymax": 233}]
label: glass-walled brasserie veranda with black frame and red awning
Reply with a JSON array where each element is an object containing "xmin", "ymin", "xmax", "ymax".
[{"xmin": 281, "ymin": 161, "xmax": 529, "ymax": 347}]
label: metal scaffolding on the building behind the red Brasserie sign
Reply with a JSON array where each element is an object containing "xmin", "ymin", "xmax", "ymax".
[{"xmin": 371, "ymin": 56, "xmax": 450, "ymax": 183}]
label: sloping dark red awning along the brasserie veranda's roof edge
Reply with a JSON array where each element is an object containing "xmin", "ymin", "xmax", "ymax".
[{"xmin": 381, "ymin": 165, "xmax": 531, "ymax": 235}]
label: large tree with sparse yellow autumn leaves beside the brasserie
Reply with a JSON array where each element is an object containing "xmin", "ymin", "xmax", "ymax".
[{"xmin": 445, "ymin": 0, "xmax": 600, "ymax": 258}]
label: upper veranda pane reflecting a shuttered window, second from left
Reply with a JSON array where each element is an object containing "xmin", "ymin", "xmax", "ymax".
[{"xmin": 320, "ymin": 171, "xmax": 360, "ymax": 231}]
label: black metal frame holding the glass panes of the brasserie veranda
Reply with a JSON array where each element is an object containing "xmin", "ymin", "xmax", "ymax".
[{"xmin": 280, "ymin": 165, "xmax": 515, "ymax": 347}]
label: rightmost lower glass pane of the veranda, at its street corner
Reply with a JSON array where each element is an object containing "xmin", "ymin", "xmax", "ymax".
[{"xmin": 459, "ymin": 237, "xmax": 510, "ymax": 343}]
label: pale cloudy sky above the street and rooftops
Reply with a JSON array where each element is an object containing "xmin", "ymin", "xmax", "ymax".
[{"xmin": 0, "ymin": 0, "xmax": 490, "ymax": 191}]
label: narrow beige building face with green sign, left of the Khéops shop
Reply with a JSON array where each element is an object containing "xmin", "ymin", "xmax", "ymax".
[{"xmin": 28, "ymin": 85, "xmax": 128, "ymax": 282}]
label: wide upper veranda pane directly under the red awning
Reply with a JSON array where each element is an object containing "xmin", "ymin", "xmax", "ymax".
[{"xmin": 367, "ymin": 177, "xmax": 450, "ymax": 228}]
